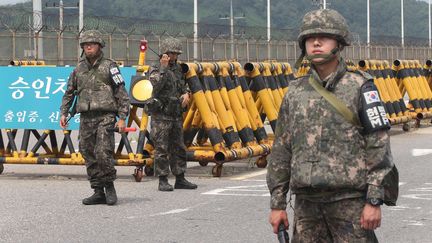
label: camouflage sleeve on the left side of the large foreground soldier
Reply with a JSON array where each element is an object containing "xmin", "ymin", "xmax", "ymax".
[{"xmin": 267, "ymin": 95, "xmax": 292, "ymax": 209}]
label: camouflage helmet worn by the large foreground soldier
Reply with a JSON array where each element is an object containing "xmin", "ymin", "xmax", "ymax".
[{"xmin": 297, "ymin": 9, "xmax": 351, "ymax": 49}]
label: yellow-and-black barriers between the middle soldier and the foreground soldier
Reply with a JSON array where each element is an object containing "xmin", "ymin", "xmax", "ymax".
[{"xmin": 176, "ymin": 62, "xmax": 292, "ymax": 176}]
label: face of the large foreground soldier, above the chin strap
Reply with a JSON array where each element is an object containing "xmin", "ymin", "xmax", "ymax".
[{"xmin": 305, "ymin": 35, "xmax": 338, "ymax": 62}]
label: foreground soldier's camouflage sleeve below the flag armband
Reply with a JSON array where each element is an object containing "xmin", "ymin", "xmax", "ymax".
[{"xmin": 365, "ymin": 130, "xmax": 393, "ymax": 199}]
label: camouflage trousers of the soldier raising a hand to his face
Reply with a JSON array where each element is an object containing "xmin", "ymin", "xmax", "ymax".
[{"xmin": 150, "ymin": 117, "xmax": 186, "ymax": 176}]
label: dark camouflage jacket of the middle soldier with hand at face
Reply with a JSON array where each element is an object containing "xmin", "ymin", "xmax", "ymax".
[{"xmin": 149, "ymin": 63, "xmax": 188, "ymax": 120}]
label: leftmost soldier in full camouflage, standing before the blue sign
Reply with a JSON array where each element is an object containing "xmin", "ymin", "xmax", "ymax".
[{"xmin": 60, "ymin": 30, "xmax": 130, "ymax": 205}]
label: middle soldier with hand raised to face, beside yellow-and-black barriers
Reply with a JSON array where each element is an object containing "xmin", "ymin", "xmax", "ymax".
[{"xmin": 149, "ymin": 38, "xmax": 197, "ymax": 191}]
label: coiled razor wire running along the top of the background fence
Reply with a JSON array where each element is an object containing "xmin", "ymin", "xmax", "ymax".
[{"xmin": 0, "ymin": 9, "xmax": 428, "ymax": 46}]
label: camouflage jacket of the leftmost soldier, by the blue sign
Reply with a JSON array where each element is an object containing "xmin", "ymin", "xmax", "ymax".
[{"xmin": 60, "ymin": 53, "xmax": 130, "ymax": 119}]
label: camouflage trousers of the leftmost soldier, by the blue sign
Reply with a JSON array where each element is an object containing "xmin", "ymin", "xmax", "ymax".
[{"xmin": 79, "ymin": 111, "xmax": 117, "ymax": 188}]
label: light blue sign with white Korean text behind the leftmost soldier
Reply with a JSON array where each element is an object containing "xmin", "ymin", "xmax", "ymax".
[{"xmin": 0, "ymin": 66, "xmax": 136, "ymax": 130}]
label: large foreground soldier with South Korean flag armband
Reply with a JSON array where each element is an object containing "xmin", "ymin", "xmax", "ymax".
[{"xmin": 267, "ymin": 9, "xmax": 393, "ymax": 242}]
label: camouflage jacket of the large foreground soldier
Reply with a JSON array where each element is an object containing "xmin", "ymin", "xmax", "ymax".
[{"xmin": 267, "ymin": 60, "xmax": 393, "ymax": 209}]
